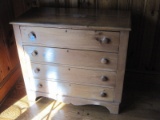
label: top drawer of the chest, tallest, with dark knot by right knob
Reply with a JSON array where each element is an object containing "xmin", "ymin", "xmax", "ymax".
[{"xmin": 20, "ymin": 26, "xmax": 119, "ymax": 52}]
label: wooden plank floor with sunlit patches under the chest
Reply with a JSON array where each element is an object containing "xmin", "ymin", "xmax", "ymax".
[{"xmin": 0, "ymin": 76, "xmax": 160, "ymax": 120}]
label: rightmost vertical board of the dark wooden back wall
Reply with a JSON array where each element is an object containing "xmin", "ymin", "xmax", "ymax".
[{"xmin": 140, "ymin": 0, "xmax": 160, "ymax": 70}]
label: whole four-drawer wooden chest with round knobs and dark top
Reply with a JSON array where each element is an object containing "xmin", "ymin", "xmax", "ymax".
[{"xmin": 11, "ymin": 8, "xmax": 130, "ymax": 114}]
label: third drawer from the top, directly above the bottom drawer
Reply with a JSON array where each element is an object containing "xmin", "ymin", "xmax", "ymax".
[{"xmin": 31, "ymin": 63, "xmax": 116, "ymax": 87}]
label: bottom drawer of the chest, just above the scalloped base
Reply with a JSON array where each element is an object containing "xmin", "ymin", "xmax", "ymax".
[{"xmin": 31, "ymin": 80, "xmax": 114, "ymax": 101}]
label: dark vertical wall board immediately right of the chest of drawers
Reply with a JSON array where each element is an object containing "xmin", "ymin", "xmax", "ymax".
[{"xmin": 127, "ymin": 0, "xmax": 146, "ymax": 71}]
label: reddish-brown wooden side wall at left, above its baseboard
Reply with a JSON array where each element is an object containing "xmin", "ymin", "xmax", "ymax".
[{"xmin": 0, "ymin": 0, "xmax": 31, "ymax": 80}]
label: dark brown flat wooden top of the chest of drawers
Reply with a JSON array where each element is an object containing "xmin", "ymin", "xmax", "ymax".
[{"xmin": 11, "ymin": 8, "xmax": 130, "ymax": 31}]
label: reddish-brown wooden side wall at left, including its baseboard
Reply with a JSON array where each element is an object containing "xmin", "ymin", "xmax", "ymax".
[{"xmin": 0, "ymin": 0, "xmax": 24, "ymax": 103}]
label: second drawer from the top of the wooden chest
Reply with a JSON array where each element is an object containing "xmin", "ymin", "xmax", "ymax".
[{"xmin": 24, "ymin": 46, "xmax": 117, "ymax": 70}]
